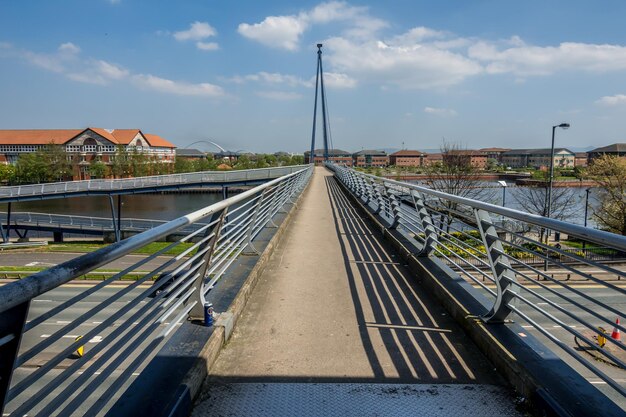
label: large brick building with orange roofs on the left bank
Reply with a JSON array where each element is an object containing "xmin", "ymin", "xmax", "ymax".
[{"xmin": 0, "ymin": 127, "xmax": 176, "ymax": 180}]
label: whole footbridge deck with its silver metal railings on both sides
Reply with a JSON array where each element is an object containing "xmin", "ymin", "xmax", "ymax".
[{"xmin": 0, "ymin": 166, "xmax": 626, "ymax": 416}]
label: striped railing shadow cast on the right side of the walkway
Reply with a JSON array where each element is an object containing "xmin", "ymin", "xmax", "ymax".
[{"xmin": 326, "ymin": 177, "xmax": 499, "ymax": 384}]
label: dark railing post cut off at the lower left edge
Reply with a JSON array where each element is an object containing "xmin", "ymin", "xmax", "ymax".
[{"xmin": 0, "ymin": 301, "xmax": 30, "ymax": 415}]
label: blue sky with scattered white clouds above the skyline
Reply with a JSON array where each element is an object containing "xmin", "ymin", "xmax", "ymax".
[{"xmin": 0, "ymin": 0, "xmax": 626, "ymax": 152}]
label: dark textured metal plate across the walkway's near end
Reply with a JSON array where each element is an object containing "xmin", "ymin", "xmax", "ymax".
[{"xmin": 192, "ymin": 383, "xmax": 523, "ymax": 417}]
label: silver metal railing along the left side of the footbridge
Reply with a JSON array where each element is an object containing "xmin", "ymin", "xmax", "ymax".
[{"xmin": 0, "ymin": 166, "xmax": 312, "ymax": 415}]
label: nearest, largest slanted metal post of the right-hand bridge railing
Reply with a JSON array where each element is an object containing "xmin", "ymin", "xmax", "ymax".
[{"xmin": 474, "ymin": 209, "xmax": 519, "ymax": 323}]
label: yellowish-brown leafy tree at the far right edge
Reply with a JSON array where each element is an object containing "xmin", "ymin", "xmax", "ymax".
[{"xmin": 587, "ymin": 155, "xmax": 626, "ymax": 235}]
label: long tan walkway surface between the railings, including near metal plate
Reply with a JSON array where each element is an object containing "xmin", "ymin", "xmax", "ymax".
[{"xmin": 193, "ymin": 168, "xmax": 519, "ymax": 417}]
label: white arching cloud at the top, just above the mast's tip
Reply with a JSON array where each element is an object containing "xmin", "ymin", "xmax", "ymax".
[{"xmin": 238, "ymin": 1, "xmax": 388, "ymax": 51}]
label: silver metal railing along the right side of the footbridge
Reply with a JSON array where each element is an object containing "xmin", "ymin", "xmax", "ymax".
[{"xmin": 327, "ymin": 164, "xmax": 626, "ymax": 396}]
